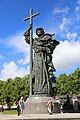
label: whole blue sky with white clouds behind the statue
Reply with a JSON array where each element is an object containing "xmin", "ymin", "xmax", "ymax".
[{"xmin": 0, "ymin": 0, "xmax": 80, "ymax": 80}]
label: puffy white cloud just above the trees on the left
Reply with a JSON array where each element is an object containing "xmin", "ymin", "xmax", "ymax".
[{"xmin": 0, "ymin": 61, "xmax": 29, "ymax": 80}]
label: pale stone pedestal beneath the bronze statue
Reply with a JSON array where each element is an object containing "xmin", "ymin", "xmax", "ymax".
[{"xmin": 23, "ymin": 96, "xmax": 60, "ymax": 114}]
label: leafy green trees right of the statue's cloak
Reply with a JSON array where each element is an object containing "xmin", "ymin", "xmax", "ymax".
[{"xmin": 56, "ymin": 68, "xmax": 80, "ymax": 95}]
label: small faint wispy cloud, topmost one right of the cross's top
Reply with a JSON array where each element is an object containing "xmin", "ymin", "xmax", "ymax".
[{"xmin": 52, "ymin": 6, "xmax": 69, "ymax": 15}]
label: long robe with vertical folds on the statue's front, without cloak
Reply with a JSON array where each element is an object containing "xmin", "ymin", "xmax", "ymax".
[{"xmin": 33, "ymin": 38, "xmax": 47, "ymax": 94}]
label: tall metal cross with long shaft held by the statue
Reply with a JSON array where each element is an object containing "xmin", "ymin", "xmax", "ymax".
[{"xmin": 24, "ymin": 9, "xmax": 39, "ymax": 96}]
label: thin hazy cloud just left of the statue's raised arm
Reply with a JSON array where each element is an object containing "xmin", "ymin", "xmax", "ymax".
[{"xmin": 7, "ymin": 32, "xmax": 29, "ymax": 54}]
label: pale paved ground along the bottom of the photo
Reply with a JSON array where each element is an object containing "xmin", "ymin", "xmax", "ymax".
[{"xmin": 0, "ymin": 113, "xmax": 80, "ymax": 120}]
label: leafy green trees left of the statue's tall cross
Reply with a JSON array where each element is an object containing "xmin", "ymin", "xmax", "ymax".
[{"xmin": 0, "ymin": 75, "xmax": 29, "ymax": 108}]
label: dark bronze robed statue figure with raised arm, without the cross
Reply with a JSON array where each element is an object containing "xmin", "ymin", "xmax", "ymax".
[{"xmin": 24, "ymin": 25, "xmax": 59, "ymax": 95}]
